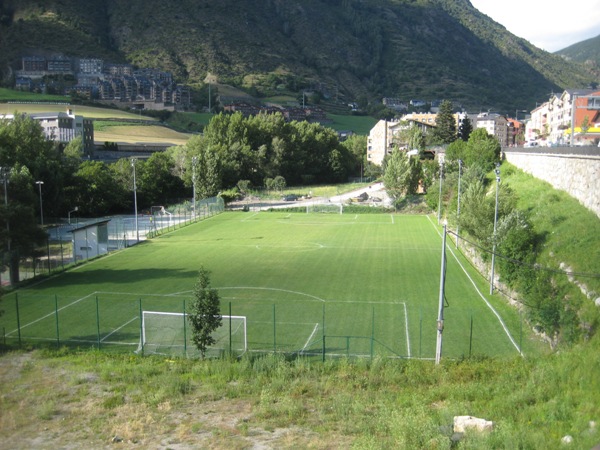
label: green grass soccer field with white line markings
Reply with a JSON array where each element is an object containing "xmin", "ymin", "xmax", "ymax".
[{"xmin": 0, "ymin": 212, "xmax": 529, "ymax": 358}]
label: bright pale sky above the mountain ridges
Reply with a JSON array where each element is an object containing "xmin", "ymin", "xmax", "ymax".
[{"xmin": 471, "ymin": 0, "xmax": 600, "ymax": 52}]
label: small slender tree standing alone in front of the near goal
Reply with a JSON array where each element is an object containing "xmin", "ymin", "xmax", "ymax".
[{"xmin": 187, "ymin": 266, "xmax": 222, "ymax": 359}]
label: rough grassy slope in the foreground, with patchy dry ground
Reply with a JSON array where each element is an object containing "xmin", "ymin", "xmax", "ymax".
[{"xmin": 0, "ymin": 338, "xmax": 600, "ymax": 449}]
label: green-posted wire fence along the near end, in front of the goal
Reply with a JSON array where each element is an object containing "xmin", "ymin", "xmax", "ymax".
[{"xmin": 0, "ymin": 292, "xmax": 524, "ymax": 360}]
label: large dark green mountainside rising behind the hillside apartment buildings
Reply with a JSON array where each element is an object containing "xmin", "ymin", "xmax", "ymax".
[{"xmin": 0, "ymin": 0, "xmax": 594, "ymax": 112}]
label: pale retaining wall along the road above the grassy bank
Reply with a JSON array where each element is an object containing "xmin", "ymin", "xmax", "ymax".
[{"xmin": 502, "ymin": 147, "xmax": 600, "ymax": 217}]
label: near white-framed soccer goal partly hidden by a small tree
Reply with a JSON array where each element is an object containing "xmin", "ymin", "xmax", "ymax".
[{"xmin": 137, "ymin": 311, "xmax": 248, "ymax": 357}]
